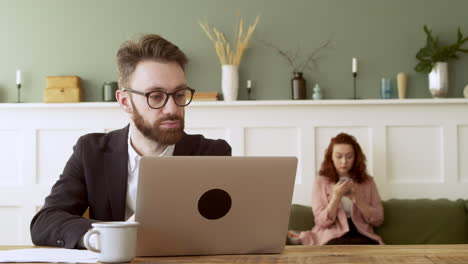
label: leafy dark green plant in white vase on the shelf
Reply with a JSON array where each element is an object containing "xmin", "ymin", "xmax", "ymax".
[{"xmin": 414, "ymin": 25, "xmax": 468, "ymax": 98}]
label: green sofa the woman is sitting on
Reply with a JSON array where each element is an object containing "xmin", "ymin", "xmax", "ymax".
[{"xmin": 289, "ymin": 199, "xmax": 468, "ymax": 245}]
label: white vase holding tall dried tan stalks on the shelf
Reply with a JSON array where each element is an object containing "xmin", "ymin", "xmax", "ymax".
[{"xmin": 198, "ymin": 16, "xmax": 260, "ymax": 101}]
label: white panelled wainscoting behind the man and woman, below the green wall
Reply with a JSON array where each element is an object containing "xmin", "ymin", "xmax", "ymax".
[{"xmin": 0, "ymin": 99, "xmax": 468, "ymax": 245}]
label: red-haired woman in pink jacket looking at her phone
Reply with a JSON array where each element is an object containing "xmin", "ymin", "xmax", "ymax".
[{"xmin": 288, "ymin": 133, "xmax": 384, "ymax": 245}]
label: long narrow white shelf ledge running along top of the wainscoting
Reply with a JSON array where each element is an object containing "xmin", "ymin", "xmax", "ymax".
[{"xmin": 0, "ymin": 98, "xmax": 468, "ymax": 109}]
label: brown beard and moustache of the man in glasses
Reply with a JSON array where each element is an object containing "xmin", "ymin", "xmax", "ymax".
[{"xmin": 132, "ymin": 102, "xmax": 184, "ymax": 145}]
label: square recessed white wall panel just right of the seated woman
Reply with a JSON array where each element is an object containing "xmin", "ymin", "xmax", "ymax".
[{"xmin": 387, "ymin": 126, "xmax": 445, "ymax": 183}]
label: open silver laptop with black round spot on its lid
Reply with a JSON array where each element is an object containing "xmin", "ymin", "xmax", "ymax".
[{"xmin": 135, "ymin": 156, "xmax": 297, "ymax": 256}]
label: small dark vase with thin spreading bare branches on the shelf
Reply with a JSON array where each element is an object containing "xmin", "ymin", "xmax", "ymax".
[{"xmin": 260, "ymin": 39, "xmax": 331, "ymax": 100}]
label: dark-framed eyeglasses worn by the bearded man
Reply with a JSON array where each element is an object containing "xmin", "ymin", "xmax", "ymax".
[{"xmin": 123, "ymin": 87, "xmax": 195, "ymax": 109}]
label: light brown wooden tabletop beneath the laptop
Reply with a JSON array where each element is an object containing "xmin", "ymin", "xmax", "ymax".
[{"xmin": 0, "ymin": 245, "xmax": 468, "ymax": 264}]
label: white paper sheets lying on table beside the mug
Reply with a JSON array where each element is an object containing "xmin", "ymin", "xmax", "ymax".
[{"xmin": 0, "ymin": 248, "xmax": 98, "ymax": 263}]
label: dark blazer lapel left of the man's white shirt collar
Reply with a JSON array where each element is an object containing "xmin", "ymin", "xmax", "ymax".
[{"xmin": 103, "ymin": 126, "xmax": 128, "ymax": 221}]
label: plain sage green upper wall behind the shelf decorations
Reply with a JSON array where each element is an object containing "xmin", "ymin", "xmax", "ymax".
[{"xmin": 0, "ymin": 0, "xmax": 468, "ymax": 102}]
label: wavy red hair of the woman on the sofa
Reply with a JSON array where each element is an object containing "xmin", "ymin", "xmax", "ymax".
[{"xmin": 319, "ymin": 133, "xmax": 369, "ymax": 183}]
